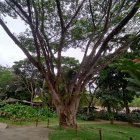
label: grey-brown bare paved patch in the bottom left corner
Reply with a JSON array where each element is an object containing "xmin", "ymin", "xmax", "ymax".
[{"xmin": 0, "ymin": 127, "xmax": 48, "ymax": 140}]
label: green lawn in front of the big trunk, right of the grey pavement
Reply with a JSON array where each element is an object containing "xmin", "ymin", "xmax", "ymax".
[{"xmin": 49, "ymin": 124, "xmax": 140, "ymax": 140}]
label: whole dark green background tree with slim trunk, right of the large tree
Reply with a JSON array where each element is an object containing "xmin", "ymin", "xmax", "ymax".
[{"xmin": 97, "ymin": 67, "xmax": 136, "ymax": 121}]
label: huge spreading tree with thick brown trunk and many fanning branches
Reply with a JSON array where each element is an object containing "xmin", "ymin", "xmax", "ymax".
[{"xmin": 0, "ymin": 0, "xmax": 140, "ymax": 126}]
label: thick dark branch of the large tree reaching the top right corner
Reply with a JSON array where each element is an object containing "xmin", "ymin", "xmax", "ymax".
[{"xmin": 79, "ymin": 0, "xmax": 140, "ymax": 89}]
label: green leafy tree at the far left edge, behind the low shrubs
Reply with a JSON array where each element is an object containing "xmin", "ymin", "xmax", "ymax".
[{"xmin": 0, "ymin": 66, "xmax": 30, "ymax": 101}]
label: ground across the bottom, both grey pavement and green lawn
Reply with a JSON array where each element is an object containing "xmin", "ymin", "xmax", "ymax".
[{"xmin": 0, "ymin": 119, "xmax": 140, "ymax": 140}]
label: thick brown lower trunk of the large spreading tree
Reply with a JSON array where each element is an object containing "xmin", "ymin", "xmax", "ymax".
[{"xmin": 56, "ymin": 95, "xmax": 80, "ymax": 127}]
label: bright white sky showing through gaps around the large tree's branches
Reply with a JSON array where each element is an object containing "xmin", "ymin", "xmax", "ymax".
[{"xmin": 0, "ymin": 18, "xmax": 83, "ymax": 67}]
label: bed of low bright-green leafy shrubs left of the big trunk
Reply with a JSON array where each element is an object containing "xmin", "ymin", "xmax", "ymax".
[{"xmin": 0, "ymin": 104, "xmax": 55, "ymax": 121}]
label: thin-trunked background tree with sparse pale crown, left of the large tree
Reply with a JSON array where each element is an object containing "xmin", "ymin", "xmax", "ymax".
[{"xmin": 13, "ymin": 59, "xmax": 44, "ymax": 103}]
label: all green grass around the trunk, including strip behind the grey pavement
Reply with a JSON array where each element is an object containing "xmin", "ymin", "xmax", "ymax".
[{"xmin": 0, "ymin": 118, "xmax": 140, "ymax": 140}]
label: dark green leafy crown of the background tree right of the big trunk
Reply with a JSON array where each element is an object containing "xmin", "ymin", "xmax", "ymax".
[{"xmin": 98, "ymin": 62, "xmax": 135, "ymax": 105}]
